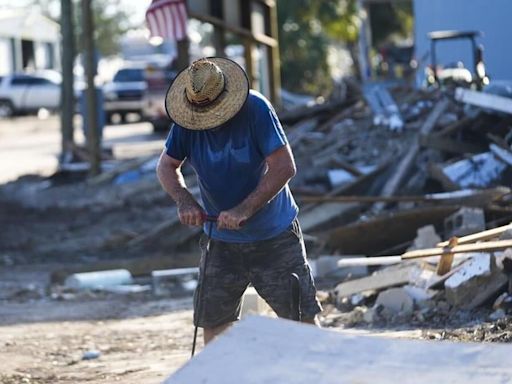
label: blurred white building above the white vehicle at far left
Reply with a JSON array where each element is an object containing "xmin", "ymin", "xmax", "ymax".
[{"xmin": 0, "ymin": 9, "xmax": 60, "ymax": 75}]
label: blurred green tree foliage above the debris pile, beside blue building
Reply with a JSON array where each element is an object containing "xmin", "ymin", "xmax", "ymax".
[{"xmin": 277, "ymin": 0, "xmax": 412, "ymax": 94}]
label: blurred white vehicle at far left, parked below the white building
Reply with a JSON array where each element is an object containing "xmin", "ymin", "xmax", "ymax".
[{"xmin": 0, "ymin": 73, "xmax": 61, "ymax": 118}]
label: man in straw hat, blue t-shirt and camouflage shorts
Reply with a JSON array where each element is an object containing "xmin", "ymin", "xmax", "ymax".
[{"xmin": 157, "ymin": 58, "xmax": 321, "ymax": 343}]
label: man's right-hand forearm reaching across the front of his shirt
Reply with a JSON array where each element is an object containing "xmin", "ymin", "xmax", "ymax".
[{"xmin": 217, "ymin": 145, "xmax": 296, "ymax": 229}]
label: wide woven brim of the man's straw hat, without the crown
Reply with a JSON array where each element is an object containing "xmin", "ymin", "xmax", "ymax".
[{"xmin": 165, "ymin": 57, "xmax": 249, "ymax": 130}]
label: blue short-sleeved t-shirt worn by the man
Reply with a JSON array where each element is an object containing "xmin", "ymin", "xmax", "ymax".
[{"xmin": 165, "ymin": 90, "xmax": 298, "ymax": 243}]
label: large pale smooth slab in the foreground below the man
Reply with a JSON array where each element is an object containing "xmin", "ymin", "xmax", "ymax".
[{"xmin": 164, "ymin": 317, "xmax": 512, "ymax": 384}]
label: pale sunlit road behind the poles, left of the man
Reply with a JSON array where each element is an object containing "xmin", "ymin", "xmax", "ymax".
[{"xmin": 0, "ymin": 115, "xmax": 168, "ymax": 184}]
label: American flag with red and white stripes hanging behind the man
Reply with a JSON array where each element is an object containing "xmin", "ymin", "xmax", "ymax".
[{"xmin": 146, "ymin": 0, "xmax": 187, "ymax": 41}]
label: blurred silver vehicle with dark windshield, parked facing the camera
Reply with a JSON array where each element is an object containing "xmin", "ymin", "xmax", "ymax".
[{"xmin": 103, "ymin": 66, "xmax": 147, "ymax": 121}]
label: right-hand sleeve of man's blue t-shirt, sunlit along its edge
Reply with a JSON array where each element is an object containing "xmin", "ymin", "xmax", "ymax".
[{"xmin": 252, "ymin": 98, "xmax": 288, "ymax": 157}]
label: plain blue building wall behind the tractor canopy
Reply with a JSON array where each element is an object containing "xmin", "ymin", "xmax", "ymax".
[{"xmin": 414, "ymin": 0, "xmax": 512, "ymax": 81}]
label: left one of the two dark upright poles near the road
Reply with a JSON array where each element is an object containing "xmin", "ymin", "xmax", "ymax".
[{"xmin": 60, "ymin": 0, "xmax": 75, "ymax": 162}]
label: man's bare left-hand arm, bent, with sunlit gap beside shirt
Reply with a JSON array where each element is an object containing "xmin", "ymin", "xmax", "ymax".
[{"xmin": 156, "ymin": 150, "xmax": 204, "ymax": 225}]
